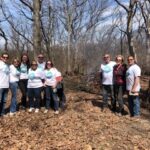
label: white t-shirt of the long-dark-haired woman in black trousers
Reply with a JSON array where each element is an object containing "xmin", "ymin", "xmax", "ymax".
[{"xmin": 20, "ymin": 63, "xmax": 28, "ymax": 79}]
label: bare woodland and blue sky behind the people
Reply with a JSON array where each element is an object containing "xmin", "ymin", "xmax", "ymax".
[{"xmin": 0, "ymin": 0, "xmax": 150, "ymax": 74}]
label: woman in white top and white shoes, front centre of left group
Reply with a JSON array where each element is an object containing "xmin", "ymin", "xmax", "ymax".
[{"xmin": 27, "ymin": 60, "xmax": 43, "ymax": 113}]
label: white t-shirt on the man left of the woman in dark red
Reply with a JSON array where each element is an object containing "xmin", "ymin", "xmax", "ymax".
[{"xmin": 100, "ymin": 61, "xmax": 116, "ymax": 85}]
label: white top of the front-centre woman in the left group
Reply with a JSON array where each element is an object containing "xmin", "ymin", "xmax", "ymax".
[{"xmin": 27, "ymin": 68, "xmax": 43, "ymax": 88}]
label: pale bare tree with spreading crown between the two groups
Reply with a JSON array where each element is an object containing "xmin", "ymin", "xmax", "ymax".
[{"xmin": 57, "ymin": 0, "xmax": 107, "ymax": 73}]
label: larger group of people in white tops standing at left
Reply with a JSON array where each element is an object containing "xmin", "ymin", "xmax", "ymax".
[{"xmin": 0, "ymin": 53, "xmax": 66, "ymax": 116}]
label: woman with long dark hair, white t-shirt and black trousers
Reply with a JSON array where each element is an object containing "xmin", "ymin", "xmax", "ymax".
[{"xmin": 19, "ymin": 53, "xmax": 30, "ymax": 109}]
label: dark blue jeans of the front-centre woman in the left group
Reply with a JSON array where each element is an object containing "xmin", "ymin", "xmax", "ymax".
[{"xmin": 28, "ymin": 87, "xmax": 42, "ymax": 108}]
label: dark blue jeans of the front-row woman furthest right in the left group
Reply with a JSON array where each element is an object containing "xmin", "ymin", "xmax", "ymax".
[{"xmin": 45, "ymin": 86, "xmax": 59, "ymax": 110}]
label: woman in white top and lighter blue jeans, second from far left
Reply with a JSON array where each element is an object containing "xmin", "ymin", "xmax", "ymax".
[{"xmin": 9, "ymin": 58, "xmax": 20, "ymax": 116}]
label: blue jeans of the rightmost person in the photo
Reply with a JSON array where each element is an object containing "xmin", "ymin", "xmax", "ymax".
[{"xmin": 128, "ymin": 95, "xmax": 140, "ymax": 117}]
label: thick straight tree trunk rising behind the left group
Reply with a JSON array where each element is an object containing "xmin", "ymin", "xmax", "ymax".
[{"xmin": 33, "ymin": 0, "xmax": 41, "ymax": 59}]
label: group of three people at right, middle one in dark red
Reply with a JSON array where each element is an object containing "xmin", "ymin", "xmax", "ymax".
[{"xmin": 100, "ymin": 54, "xmax": 141, "ymax": 117}]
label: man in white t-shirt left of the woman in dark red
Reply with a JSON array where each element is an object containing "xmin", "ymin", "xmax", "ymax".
[{"xmin": 100, "ymin": 54, "xmax": 116, "ymax": 110}]
